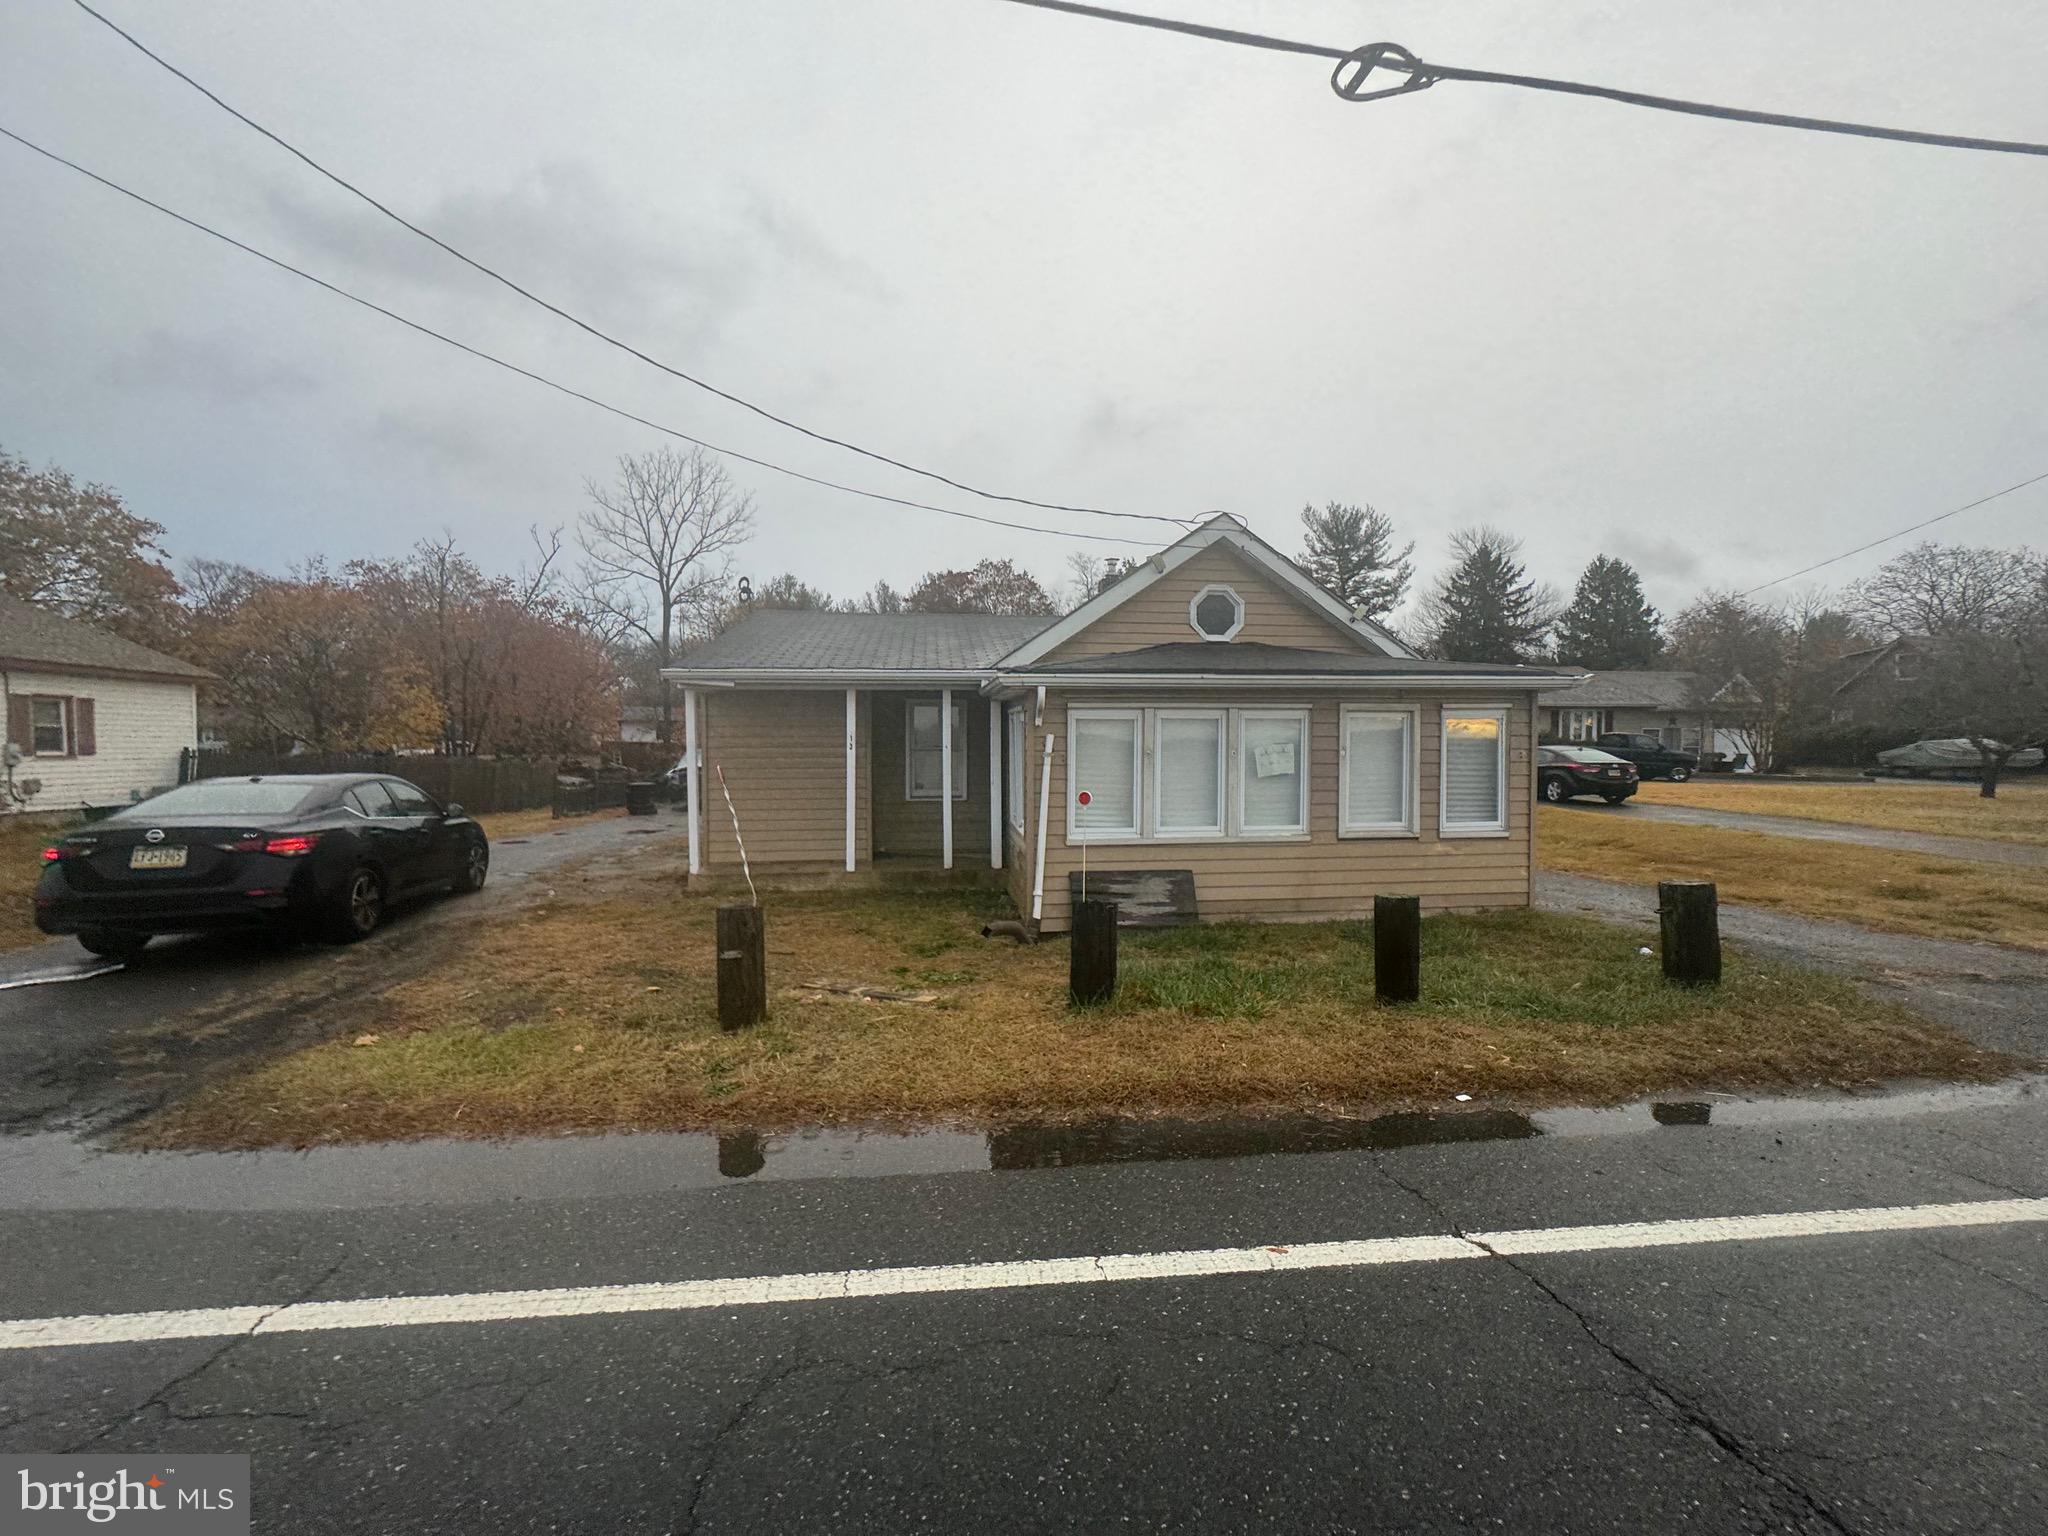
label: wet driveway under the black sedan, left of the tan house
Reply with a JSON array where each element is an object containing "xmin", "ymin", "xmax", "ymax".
[{"xmin": 0, "ymin": 815, "xmax": 684, "ymax": 1133}]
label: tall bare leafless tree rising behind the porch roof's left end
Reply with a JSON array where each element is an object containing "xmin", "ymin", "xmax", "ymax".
[{"xmin": 575, "ymin": 446, "xmax": 754, "ymax": 741}]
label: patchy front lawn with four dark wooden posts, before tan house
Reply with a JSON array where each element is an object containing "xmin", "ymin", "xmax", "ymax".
[{"xmin": 133, "ymin": 872, "xmax": 2013, "ymax": 1147}]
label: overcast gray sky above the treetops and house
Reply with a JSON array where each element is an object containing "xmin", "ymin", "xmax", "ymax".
[{"xmin": 0, "ymin": 0, "xmax": 2048, "ymax": 626}]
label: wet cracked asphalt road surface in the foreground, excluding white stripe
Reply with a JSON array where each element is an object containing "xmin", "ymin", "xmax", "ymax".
[{"xmin": 0, "ymin": 1096, "xmax": 2048, "ymax": 1536}]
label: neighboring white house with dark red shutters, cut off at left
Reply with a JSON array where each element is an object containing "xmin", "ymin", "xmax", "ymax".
[{"xmin": 0, "ymin": 596, "xmax": 209, "ymax": 815}]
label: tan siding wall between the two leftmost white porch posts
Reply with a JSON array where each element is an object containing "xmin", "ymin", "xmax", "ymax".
[{"xmin": 698, "ymin": 688, "xmax": 874, "ymax": 870}]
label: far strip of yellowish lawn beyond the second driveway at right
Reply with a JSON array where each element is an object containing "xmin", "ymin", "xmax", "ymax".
[{"xmin": 1636, "ymin": 778, "xmax": 2048, "ymax": 848}]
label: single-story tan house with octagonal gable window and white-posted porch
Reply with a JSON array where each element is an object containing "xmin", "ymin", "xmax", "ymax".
[{"xmin": 666, "ymin": 514, "xmax": 1577, "ymax": 932}]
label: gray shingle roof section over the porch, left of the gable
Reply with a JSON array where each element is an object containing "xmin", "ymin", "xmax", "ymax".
[{"xmin": 676, "ymin": 608, "xmax": 1053, "ymax": 672}]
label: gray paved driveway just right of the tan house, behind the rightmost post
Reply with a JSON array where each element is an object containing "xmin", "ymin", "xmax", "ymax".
[{"xmin": 1536, "ymin": 872, "xmax": 2048, "ymax": 1061}]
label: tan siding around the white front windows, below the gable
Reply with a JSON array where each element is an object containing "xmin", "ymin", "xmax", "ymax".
[{"xmin": 1032, "ymin": 690, "xmax": 1534, "ymax": 932}]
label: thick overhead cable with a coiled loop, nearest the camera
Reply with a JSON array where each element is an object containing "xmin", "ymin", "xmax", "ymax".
[{"xmin": 991, "ymin": 0, "xmax": 2048, "ymax": 156}]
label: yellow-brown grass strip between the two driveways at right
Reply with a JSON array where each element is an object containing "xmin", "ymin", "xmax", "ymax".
[{"xmin": 1536, "ymin": 806, "xmax": 2048, "ymax": 950}]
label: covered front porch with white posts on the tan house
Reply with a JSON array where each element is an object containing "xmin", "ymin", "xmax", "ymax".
[{"xmin": 682, "ymin": 680, "xmax": 1004, "ymax": 879}]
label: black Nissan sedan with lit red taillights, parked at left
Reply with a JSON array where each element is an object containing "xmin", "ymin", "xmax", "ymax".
[{"xmin": 35, "ymin": 774, "xmax": 492, "ymax": 956}]
